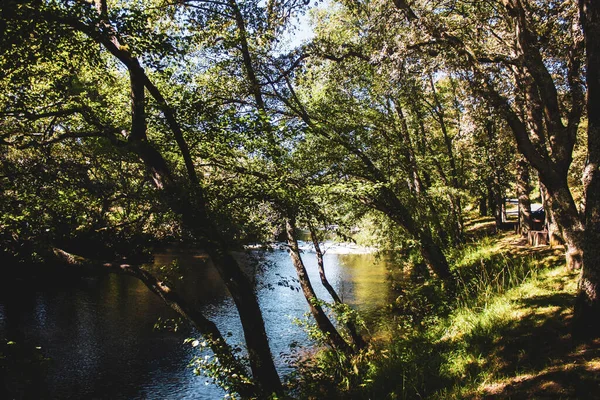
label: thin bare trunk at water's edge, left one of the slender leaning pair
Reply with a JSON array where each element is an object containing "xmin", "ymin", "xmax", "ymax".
[{"xmin": 285, "ymin": 218, "xmax": 353, "ymax": 354}]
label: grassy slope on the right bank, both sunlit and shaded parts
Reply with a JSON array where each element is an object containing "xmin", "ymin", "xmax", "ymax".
[{"xmin": 418, "ymin": 234, "xmax": 600, "ymax": 399}]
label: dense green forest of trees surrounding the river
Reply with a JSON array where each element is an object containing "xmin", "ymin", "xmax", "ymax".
[{"xmin": 0, "ymin": 0, "xmax": 600, "ymax": 398}]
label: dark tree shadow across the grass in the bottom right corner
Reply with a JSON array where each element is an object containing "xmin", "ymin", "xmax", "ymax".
[{"xmin": 460, "ymin": 293, "xmax": 600, "ymax": 399}]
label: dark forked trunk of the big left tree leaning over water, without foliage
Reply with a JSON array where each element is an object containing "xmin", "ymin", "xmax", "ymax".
[{"xmin": 68, "ymin": 4, "xmax": 282, "ymax": 395}]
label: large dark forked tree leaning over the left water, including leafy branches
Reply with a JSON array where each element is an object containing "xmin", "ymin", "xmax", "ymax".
[{"xmin": 3, "ymin": 1, "xmax": 281, "ymax": 394}]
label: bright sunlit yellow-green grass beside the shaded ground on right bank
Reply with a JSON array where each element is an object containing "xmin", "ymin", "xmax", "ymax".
[{"xmin": 432, "ymin": 252, "xmax": 576, "ymax": 399}]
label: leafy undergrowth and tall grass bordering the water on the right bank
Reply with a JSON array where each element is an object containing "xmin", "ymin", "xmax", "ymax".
[{"xmin": 293, "ymin": 233, "xmax": 574, "ymax": 399}]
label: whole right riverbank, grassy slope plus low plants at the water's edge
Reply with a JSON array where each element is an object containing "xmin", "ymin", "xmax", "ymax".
[{"xmin": 292, "ymin": 227, "xmax": 600, "ymax": 399}]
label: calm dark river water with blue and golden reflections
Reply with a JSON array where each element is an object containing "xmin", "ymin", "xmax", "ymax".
[{"xmin": 0, "ymin": 244, "xmax": 388, "ymax": 399}]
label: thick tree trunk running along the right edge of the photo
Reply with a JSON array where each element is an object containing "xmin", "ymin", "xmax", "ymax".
[{"xmin": 574, "ymin": 0, "xmax": 600, "ymax": 337}]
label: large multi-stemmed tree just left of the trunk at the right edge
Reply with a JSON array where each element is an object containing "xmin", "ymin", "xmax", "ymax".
[{"xmin": 386, "ymin": 0, "xmax": 584, "ymax": 268}]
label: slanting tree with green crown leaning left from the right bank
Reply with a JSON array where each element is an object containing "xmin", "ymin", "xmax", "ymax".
[{"xmin": 280, "ymin": 27, "xmax": 460, "ymax": 283}]
